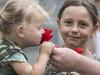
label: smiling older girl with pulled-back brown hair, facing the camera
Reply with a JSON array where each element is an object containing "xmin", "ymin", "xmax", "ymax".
[{"xmin": 46, "ymin": 0, "xmax": 98, "ymax": 75}]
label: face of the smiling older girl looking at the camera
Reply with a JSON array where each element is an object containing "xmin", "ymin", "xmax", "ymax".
[{"xmin": 58, "ymin": 6, "xmax": 94, "ymax": 48}]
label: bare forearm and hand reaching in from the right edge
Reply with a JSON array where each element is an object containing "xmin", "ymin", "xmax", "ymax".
[{"xmin": 52, "ymin": 48, "xmax": 100, "ymax": 75}]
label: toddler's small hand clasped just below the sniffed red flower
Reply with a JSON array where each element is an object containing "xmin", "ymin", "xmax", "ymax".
[{"xmin": 40, "ymin": 41, "xmax": 54, "ymax": 56}]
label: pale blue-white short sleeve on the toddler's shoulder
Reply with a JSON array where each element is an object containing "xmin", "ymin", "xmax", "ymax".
[{"xmin": 2, "ymin": 53, "xmax": 27, "ymax": 62}]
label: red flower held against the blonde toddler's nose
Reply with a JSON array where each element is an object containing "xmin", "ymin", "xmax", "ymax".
[{"xmin": 41, "ymin": 28, "xmax": 53, "ymax": 43}]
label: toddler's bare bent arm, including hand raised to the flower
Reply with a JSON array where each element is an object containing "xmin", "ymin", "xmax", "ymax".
[{"xmin": 11, "ymin": 42, "xmax": 54, "ymax": 75}]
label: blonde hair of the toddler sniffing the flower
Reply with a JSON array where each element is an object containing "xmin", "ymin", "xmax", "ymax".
[{"xmin": 0, "ymin": 0, "xmax": 48, "ymax": 33}]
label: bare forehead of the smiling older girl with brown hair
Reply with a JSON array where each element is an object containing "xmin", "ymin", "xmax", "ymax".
[{"xmin": 62, "ymin": 6, "xmax": 91, "ymax": 19}]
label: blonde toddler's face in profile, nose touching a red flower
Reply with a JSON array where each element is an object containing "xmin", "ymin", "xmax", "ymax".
[{"xmin": 24, "ymin": 19, "xmax": 44, "ymax": 46}]
